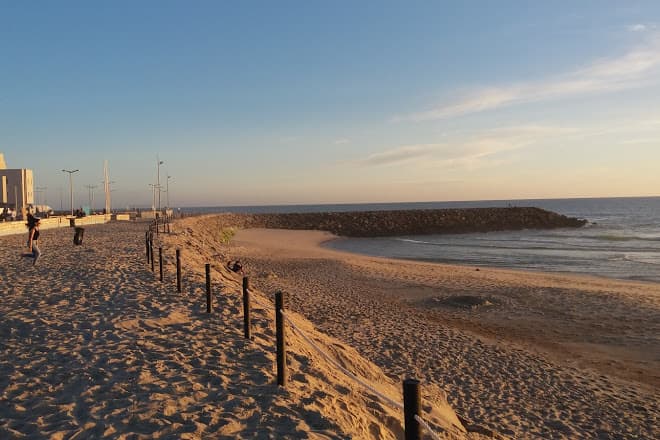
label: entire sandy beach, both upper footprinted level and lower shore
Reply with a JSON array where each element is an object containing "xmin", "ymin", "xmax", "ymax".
[{"xmin": 0, "ymin": 217, "xmax": 660, "ymax": 439}]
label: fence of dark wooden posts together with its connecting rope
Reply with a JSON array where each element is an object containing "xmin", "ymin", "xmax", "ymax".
[{"xmin": 140, "ymin": 222, "xmax": 457, "ymax": 440}]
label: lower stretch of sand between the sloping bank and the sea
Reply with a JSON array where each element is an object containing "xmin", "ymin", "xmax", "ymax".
[{"xmin": 227, "ymin": 225, "xmax": 660, "ymax": 439}]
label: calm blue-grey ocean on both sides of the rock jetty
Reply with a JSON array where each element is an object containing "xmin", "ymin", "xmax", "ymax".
[{"xmin": 185, "ymin": 197, "xmax": 660, "ymax": 283}]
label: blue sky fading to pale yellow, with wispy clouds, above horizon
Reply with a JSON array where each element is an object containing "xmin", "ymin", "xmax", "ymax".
[{"xmin": 0, "ymin": 0, "xmax": 660, "ymax": 209}]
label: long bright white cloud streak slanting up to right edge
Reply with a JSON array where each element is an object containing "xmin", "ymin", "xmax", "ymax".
[{"xmin": 395, "ymin": 35, "xmax": 660, "ymax": 122}]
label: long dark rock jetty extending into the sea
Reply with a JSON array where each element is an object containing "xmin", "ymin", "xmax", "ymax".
[{"xmin": 205, "ymin": 207, "xmax": 587, "ymax": 237}]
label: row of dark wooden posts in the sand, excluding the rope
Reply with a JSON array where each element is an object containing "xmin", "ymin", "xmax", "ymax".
[{"xmin": 146, "ymin": 220, "xmax": 428, "ymax": 440}]
